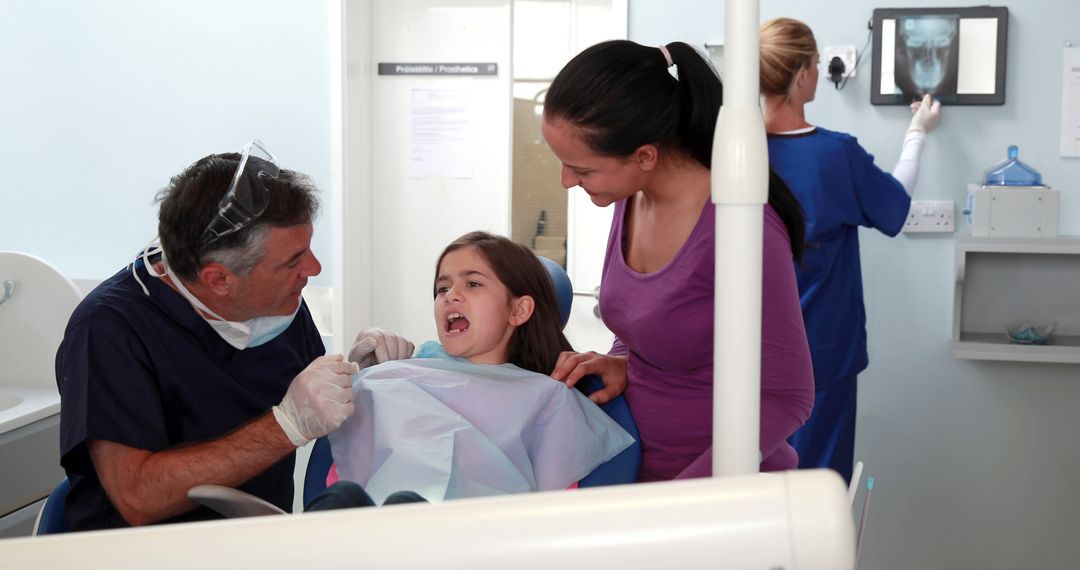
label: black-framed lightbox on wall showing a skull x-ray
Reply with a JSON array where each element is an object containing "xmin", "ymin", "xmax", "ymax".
[{"xmin": 870, "ymin": 6, "xmax": 1009, "ymax": 105}]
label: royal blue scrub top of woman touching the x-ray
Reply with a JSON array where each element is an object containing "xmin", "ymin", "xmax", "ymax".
[{"xmin": 768, "ymin": 127, "xmax": 912, "ymax": 390}]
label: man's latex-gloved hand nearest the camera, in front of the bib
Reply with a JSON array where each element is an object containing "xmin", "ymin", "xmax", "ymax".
[{"xmin": 273, "ymin": 354, "xmax": 360, "ymax": 447}]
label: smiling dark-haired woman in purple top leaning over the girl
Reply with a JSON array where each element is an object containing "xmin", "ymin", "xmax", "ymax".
[{"xmin": 541, "ymin": 40, "xmax": 813, "ymax": 480}]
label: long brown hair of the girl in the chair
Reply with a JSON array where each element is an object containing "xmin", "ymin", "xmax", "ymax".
[{"xmin": 433, "ymin": 231, "xmax": 573, "ymax": 375}]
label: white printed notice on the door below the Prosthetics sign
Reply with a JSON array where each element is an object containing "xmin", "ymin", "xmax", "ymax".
[{"xmin": 409, "ymin": 89, "xmax": 473, "ymax": 178}]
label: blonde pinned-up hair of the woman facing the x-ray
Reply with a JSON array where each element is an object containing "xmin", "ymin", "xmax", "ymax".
[{"xmin": 760, "ymin": 18, "xmax": 818, "ymax": 99}]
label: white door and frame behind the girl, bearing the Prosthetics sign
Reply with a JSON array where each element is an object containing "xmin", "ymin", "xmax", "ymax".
[{"xmin": 342, "ymin": 0, "xmax": 512, "ymax": 349}]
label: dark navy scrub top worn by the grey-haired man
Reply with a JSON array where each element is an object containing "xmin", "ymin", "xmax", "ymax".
[{"xmin": 56, "ymin": 258, "xmax": 325, "ymax": 530}]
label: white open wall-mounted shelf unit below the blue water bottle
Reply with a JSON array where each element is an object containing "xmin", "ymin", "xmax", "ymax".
[{"xmin": 953, "ymin": 236, "xmax": 1080, "ymax": 363}]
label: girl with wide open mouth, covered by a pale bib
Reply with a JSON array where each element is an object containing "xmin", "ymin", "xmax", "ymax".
[{"xmin": 329, "ymin": 232, "xmax": 633, "ymax": 501}]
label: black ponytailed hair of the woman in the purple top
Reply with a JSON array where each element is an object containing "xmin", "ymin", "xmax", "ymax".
[{"xmin": 543, "ymin": 40, "xmax": 806, "ymax": 260}]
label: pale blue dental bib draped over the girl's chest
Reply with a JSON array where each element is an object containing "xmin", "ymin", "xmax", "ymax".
[{"xmin": 329, "ymin": 347, "xmax": 633, "ymax": 503}]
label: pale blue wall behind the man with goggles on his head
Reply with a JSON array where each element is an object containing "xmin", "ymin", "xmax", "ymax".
[{"xmin": 0, "ymin": 0, "xmax": 334, "ymax": 285}]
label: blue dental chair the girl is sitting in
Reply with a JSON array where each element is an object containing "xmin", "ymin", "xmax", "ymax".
[{"xmin": 303, "ymin": 256, "xmax": 642, "ymax": 505}]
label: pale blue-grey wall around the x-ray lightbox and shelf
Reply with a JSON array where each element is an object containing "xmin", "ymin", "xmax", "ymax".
[{"xmin": 630, "ymin": 0, "xmax": 1080, "ymax": 569}]
